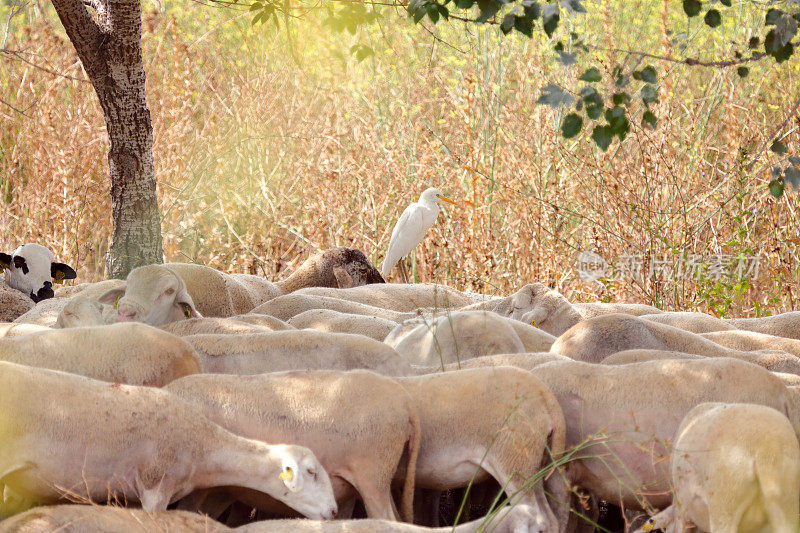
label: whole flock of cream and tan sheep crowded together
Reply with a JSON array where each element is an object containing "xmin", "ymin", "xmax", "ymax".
[{"xmin": 0, "ymin": 244, "xmax": 800, "ymax": 533}]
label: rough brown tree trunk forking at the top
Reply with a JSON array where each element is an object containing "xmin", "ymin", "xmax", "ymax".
[{"xmin": 53, "ymin": 0, "xmax": 163, "ymax": 278}]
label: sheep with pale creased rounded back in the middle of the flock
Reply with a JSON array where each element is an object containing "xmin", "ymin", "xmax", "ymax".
[{"xmin": 384, "ymin": 311, "xmax": 550, "ymax": 366}]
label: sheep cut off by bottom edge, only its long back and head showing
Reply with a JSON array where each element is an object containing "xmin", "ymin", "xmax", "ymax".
[{"xmin": 235, "ymin": 503, "xmax": 544, "ymax": 533}]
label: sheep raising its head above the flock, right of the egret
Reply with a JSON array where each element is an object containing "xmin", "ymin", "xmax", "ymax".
[{"xmin": 462, "ymin": 283, "xmax": 583, "ymax": 336}]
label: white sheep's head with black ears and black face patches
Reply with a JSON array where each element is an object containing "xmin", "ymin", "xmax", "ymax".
[{"xmin": 0, "ymin": 244, "xmax": 77, "ymax": 302}]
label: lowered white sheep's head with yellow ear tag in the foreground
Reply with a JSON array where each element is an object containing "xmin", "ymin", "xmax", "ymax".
[{"xmin": 272, "ymin": 445, "xmax": 337, "ymax": 520}]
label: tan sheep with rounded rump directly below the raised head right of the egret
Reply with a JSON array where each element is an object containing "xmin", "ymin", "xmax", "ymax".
[{"xmin": 550, "ymin": 314, "xmax": 800, "ymax": 374}]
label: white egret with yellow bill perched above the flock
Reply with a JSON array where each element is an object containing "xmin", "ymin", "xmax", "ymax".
[{"xmin": 381, "ymin": 187, "xmax": 458, "ymax": 282}]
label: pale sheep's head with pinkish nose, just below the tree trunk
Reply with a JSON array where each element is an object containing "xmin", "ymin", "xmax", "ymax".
[{"xmin": 98, "ymin": 265, "xmax": 201, "ymax": 326}]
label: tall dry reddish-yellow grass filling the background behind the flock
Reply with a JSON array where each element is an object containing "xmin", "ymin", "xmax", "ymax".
[{"xmin": 0, "ymin": 0, "xmax": 800, "ymax": 316}]
